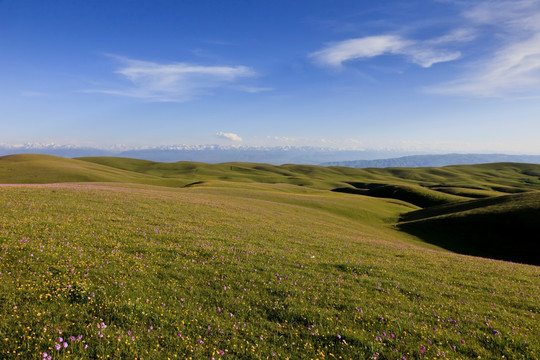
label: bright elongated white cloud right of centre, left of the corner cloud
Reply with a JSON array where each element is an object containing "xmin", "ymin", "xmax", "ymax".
[{"xmin": 310, "ymin": 34, "xmax": 463, "ymax": 68}]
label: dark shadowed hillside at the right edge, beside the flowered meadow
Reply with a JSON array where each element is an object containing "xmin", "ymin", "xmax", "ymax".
[{"xmin": 400, "ymin": 192, "xmax": 540, "ymax": 265}]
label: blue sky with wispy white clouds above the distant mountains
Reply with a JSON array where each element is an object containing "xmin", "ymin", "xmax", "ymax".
[{"xmin": 0, "ymin": 0, "xmax": 540, "ymax": 154}]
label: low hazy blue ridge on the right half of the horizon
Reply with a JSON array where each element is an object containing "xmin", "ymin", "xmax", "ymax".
[{"xmin": 321, "ymin": 154, "xmax": 540, "ymax": 168}]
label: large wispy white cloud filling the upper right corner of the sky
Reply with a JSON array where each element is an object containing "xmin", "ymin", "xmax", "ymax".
[{"xmin": 430, "ymin": 0, "xmax": 540, "ymax": 97}]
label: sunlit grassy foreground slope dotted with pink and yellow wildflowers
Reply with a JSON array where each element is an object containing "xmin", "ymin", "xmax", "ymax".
[{"xmin": 0, "ymin": 184, "xmax": 540, "ymax": 359}]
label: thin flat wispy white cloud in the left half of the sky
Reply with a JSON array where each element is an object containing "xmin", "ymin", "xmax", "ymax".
[{"xmin": 86, "ymin": 56, "xmax": 256, "ymax": 102}]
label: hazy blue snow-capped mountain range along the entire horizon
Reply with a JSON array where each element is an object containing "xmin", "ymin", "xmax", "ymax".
[{"xmin": 0, "ymin": 143, "xmax": 540, "ymax": 168}]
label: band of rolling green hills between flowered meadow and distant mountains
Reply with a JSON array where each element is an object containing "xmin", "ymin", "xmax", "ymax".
[{"xmin": 4, "ymin": 154, "xmax": 540, "ymax": 195}]
